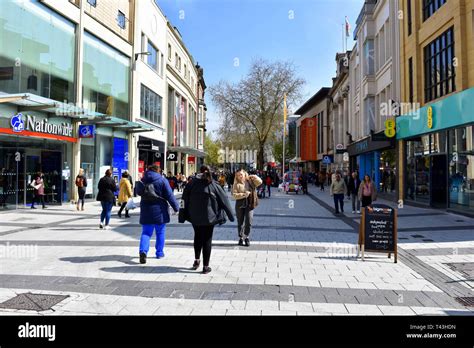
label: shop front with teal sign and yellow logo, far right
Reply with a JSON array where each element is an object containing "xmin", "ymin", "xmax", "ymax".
[{"xmin": 397, "ymin": 88, "xmax": 474, "ymax": 215}]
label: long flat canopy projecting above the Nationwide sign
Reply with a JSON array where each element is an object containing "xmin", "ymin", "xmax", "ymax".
[{"xmin": 0, "ymin": 93, "xmax": 154, "ymax": 133}]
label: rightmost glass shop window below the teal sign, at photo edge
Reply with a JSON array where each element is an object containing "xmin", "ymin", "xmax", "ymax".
[{"xmin": 448, "ymin": 126, "xmax": 474, "ymax": 210}]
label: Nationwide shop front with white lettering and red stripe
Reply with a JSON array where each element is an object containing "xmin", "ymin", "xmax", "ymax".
[{"xmin": 0, "ymin": 104, "xmax": 77, "ymax": 209}]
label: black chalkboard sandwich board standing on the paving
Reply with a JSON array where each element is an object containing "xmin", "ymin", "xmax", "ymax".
[{"xmin": 359, "ymin": 204, "xmax": 398, "ymax": 263}]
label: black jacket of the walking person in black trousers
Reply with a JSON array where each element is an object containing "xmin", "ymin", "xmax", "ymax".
[{"xmin": 183, "ymin": 175, "xmax": 234, "ymax": 226}]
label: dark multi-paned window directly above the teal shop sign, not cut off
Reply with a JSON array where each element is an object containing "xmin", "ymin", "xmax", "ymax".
[{"xmin": 424, "ymin": 27, "xmax": 456, "ymax": 103}]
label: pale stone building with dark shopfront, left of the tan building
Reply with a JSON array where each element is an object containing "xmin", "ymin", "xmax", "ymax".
[{"xmin": 348, "ymin": 0, "xmax": 400, "ymax": 199}]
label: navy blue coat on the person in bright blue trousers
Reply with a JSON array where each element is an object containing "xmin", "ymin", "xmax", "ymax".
[{"xmin": 137, "ymin": 170, "xmax": 179, "ymax": 225}]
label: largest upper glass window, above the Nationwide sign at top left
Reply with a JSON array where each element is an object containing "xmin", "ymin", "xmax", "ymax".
[{"xmin": 0, "ymin": 1, "xmax": 75, "ymax": 102}]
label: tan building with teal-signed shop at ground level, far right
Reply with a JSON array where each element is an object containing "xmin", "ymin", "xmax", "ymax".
[{"xmin": 396, "ymin": 0, "xmax": 474, "ymax": 214}]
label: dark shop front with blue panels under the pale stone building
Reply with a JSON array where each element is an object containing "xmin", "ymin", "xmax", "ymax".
[{"xmin": 347, "ymin": 134, "xmax": 397, "ymax": 193}]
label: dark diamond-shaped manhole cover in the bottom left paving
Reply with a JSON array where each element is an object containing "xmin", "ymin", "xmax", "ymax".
[{"xmin": 0, "ymin": 293, "xmax": 69, "ymax": 312}]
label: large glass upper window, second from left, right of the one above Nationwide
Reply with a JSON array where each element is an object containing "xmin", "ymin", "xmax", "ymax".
[{"xmin": 83, "ymin": 32, "xmax": 130, "ymax": 119}]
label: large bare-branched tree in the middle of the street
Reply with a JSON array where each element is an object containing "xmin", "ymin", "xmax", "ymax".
[{"xmin": 210, "ymin": 59, "xmax": 305, "ymax": 169}]
